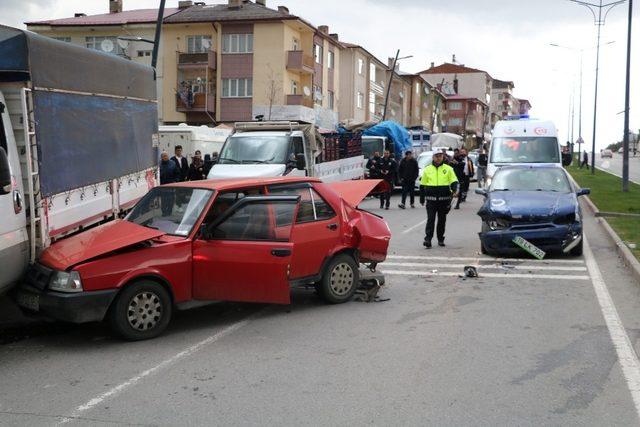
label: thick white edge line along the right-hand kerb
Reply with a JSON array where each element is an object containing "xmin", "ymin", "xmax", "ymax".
[{"xmin": 584, "ymin": 237, "xmax": 640, "ymax": 417}]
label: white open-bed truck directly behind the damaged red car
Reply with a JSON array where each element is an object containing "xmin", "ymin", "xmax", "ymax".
[{"xmin": 208, "ymin": 121, "xmax": 364, "ymax": 182}]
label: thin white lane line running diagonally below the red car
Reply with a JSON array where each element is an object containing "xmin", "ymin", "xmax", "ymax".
[{"xmin": 60, "ymin": 312, "xmax": 259, "ymax": 424}]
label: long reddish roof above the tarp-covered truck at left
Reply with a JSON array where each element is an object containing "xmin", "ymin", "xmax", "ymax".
[{"xmin": 26, "ymin": 7, "xmax": 179, "ymax": 26}]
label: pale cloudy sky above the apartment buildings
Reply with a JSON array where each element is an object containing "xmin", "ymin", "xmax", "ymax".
[{"xmin": 0, "ymin": 0, "xmax": 640, "ymax": 148}]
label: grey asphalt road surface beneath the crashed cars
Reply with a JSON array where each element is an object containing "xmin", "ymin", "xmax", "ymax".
[{"xmin": 0, "ymin": 191, "xmax": 640, "ymax": 426}]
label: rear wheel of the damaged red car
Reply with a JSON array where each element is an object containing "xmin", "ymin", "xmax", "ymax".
[{"xmin": 319, "ymin": 254, "xmax": 359, "ymax": 304}]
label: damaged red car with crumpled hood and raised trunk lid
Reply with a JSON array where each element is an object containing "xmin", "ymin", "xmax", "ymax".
[{"xmin": 16, "ymin": 178, "xmax": 391, "ymax": 340}]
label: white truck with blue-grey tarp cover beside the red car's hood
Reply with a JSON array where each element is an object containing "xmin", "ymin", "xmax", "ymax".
[{"xmin": 0, "ymin": 25, "xmax": 158, "ymax": 294}]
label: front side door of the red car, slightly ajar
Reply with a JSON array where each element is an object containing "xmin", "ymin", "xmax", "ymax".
[{"xmin": 193, "ymin": 196, "xmax": 299, "ymax": 304}]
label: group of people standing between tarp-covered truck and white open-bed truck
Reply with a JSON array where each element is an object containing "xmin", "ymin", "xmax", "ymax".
[{"xmin": 160, "ymin": 145, "xmax": 218, "ymax": 184}]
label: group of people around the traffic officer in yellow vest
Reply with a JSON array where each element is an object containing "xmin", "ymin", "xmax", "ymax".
[{"xmin": 366, "ymin": 147, "xmax": 488, "ymax": 248}]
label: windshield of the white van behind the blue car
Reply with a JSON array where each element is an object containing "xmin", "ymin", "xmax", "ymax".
[{"xmin": 489, "ymin": 136, "xmax": 560, "ymax": 163}]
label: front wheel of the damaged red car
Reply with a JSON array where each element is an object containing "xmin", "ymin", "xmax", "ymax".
[{"xmin": 109, "ymin": 281, "xmax": 172, "ymax": 341}]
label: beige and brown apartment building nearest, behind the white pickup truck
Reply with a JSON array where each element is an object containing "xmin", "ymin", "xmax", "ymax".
[{"xmin": 163, "ymin": 0, "xmax": 342, "ymax": 128}]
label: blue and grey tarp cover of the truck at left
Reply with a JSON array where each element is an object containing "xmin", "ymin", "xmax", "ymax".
[{"xmin": 0, "ymin": 25, "xmax": 158, "ymax": 196}]
